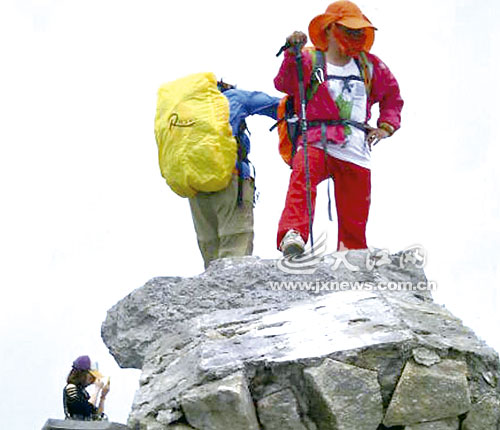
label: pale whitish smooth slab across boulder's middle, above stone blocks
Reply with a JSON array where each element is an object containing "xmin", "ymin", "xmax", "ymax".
[{"xmin": 124, "ymin": 291, "xmax": 412, "ymax": 427}]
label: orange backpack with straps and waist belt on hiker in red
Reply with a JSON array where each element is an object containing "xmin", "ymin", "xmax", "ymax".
[{"xmin": 271, "ymin": 48, "xmax": 373, "ymax": 166}]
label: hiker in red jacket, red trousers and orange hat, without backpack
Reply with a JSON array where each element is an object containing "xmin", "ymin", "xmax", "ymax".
[{"xmin": 274, "ymin": 1, "xmax": 403, "ymax": 255}]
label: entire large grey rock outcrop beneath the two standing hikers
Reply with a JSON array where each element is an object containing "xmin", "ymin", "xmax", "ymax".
[{"xmin": 102, "ymin": 250, "xmax": 500, "ymax": 430}]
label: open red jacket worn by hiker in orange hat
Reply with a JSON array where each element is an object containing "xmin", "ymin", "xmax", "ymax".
[{"xmin": 274, "ymin": 49, "xmax": 403, "ymax": 143}]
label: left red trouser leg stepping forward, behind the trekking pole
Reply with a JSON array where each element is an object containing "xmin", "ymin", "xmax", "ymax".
[{"xmin": 277, "ymin": 146, "xmax": 331, "ymax": 249}]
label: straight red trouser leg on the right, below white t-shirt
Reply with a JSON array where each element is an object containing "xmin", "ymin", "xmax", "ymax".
[{"xmin": 331, "ymin": 157, "xmax": 371, "ymax": 251}]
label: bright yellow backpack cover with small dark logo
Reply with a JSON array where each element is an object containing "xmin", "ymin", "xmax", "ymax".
[{"xmin": 155, "ymin": 73, "xmax": 237, "ymax": 197}]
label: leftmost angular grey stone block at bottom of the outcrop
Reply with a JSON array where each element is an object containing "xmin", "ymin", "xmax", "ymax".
[{"xmin": 181, "ymin": 372, "xmax": 259, "ymax": 430}]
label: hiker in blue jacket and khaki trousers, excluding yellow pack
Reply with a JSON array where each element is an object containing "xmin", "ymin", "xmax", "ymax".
[{"xmin": 189, "ymin": 82, "xmax": 280, "ymax": 268}]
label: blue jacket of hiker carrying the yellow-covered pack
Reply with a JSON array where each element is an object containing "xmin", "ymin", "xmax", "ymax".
[{"xmin": 222, "ymin": 88, "xmax": 280, "ymax": 179}]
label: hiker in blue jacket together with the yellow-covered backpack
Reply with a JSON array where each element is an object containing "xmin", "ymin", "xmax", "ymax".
[{"xmin": 155, "ymin": 73, "xmax": 280, "ymax": 268}]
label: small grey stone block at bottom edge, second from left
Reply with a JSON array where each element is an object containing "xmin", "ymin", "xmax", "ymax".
[{"xmin": 257, "ymin": 388, "xmax": 307, "ymax": 430}]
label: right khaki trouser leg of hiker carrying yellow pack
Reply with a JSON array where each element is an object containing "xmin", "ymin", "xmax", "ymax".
[{"xmin": 217, "ymin": 175, "xmax": 255, "ymax": 258}]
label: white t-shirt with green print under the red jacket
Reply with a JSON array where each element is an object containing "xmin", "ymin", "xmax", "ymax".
[{"xmin": 313, "ymin": 59, "xmax": 370, "ymax": 169}]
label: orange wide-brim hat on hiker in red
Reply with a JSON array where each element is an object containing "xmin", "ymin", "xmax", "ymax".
[{"xmin": 309, "ymin": 0, "xmax": 376, "ymax": 52}]
